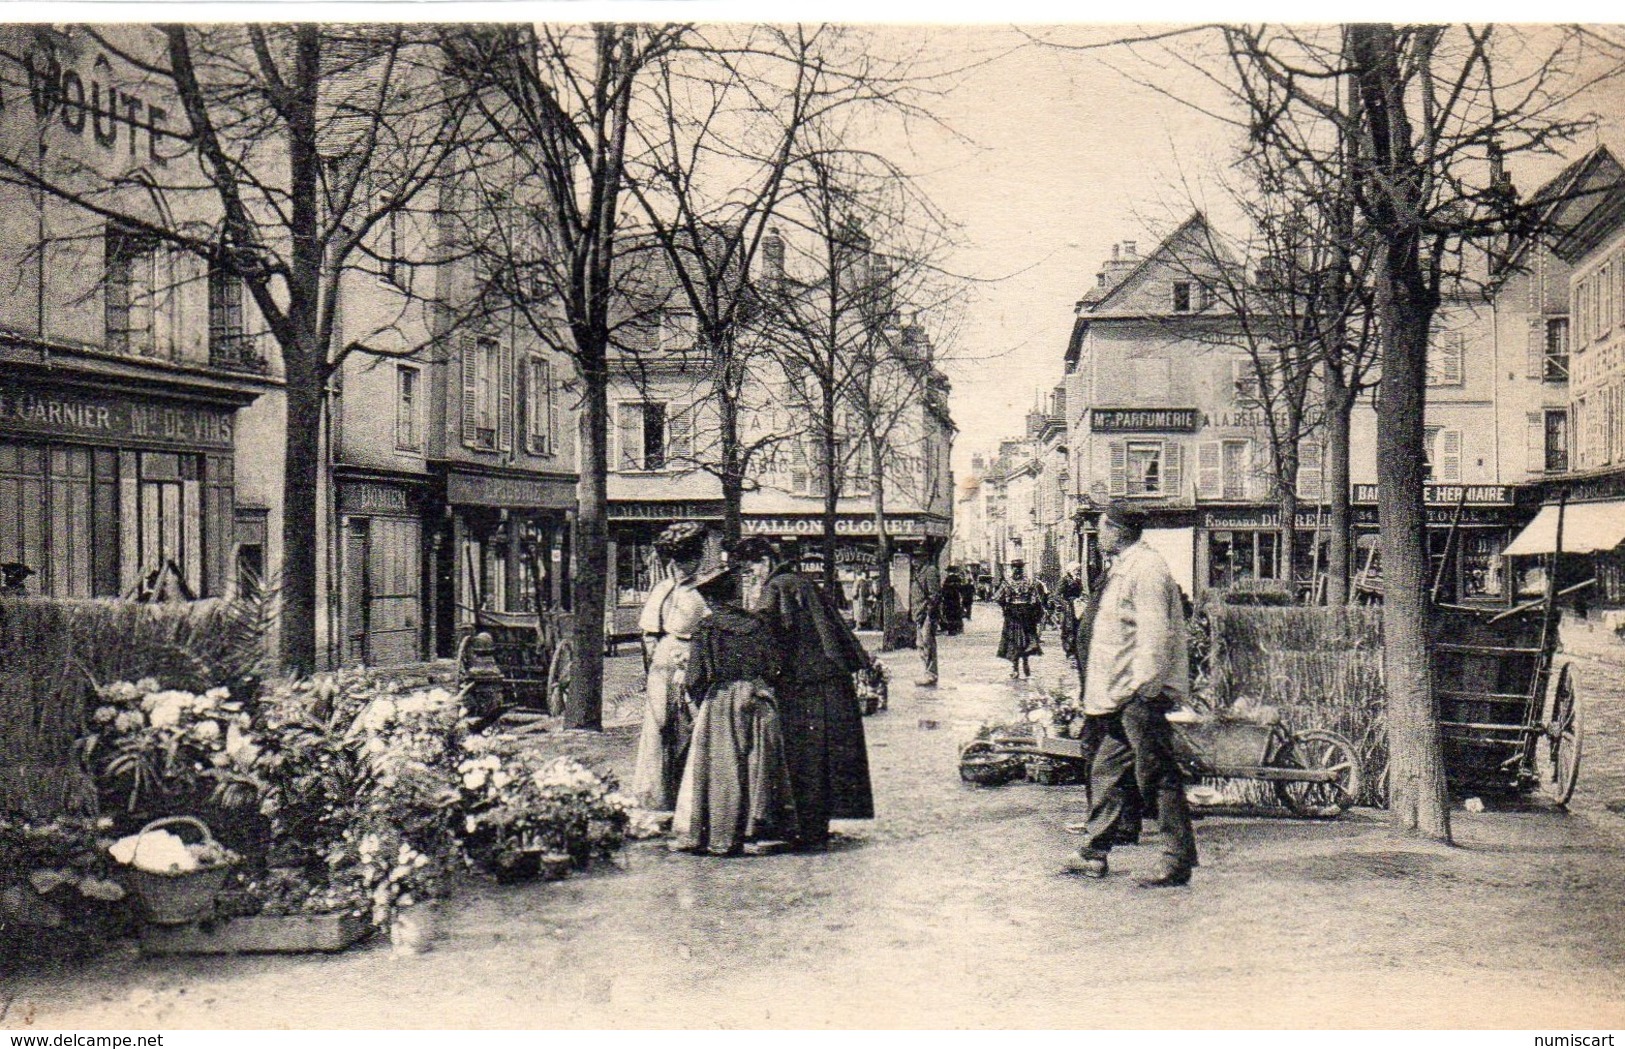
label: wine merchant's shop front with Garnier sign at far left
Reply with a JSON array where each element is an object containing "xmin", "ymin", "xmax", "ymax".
[{"xmin": 0, "ymin": 372, "xmax": 260, "ymax": 598}]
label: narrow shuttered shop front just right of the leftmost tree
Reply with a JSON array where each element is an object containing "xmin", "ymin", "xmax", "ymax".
[{"xmin": 335, "ymin": 473, "xmax": 432, "ymax": 666}]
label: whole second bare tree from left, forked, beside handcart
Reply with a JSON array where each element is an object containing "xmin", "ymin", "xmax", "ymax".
[{"xmin": 444, "ymin": 23, "xmax": 689, "ymax": 729}]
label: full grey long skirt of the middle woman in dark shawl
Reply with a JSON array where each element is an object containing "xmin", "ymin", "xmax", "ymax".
[{"xmin": 671, "ymin": 680, "xmax": 796, "ymax": 856}]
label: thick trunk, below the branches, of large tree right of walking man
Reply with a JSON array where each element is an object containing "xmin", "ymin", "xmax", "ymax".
[{"xmin": 1376, "ymin": 250, "xmax": 1450, "ymax": 841}]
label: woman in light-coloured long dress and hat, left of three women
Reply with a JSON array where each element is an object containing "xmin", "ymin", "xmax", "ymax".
[{"xmin": 632, "ymin": 521, "xmax": 710, "ymax": 812}]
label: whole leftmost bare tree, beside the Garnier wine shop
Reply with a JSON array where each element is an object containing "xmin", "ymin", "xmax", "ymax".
[{"xmin": 0, "ymin": 24, "xmax": 465, "ymax": 672}]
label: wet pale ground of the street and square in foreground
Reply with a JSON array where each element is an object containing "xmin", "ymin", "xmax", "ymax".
[{"xmin": 9, "ymin": 606, "xmax": 1625, "ymax": 1030}]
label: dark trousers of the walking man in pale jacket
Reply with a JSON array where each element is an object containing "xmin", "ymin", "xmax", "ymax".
[{"xmin": 1086, "ymin": 698, "xmax": 1196, "ymax": 870}]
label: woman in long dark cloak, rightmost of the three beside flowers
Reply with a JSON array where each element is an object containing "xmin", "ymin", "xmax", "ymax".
[{"xmin": 731, "ymin": 536, "xmax": 874, "ymax": 849}]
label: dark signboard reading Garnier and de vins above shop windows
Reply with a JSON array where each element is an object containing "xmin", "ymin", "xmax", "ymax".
[{"xmin": 0, "ymin": 383, "xmax": 231, "ymax": 450}]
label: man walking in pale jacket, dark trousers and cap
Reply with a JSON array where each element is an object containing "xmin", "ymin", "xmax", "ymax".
[{"xmin": 1068, "ymin": 503, "xmax": 1196, "ymax": 888}]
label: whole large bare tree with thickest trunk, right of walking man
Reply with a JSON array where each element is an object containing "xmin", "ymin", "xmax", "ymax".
[{"xmin": 1224, "ymin": 24, "xmax": 1589, "ymax": 841}]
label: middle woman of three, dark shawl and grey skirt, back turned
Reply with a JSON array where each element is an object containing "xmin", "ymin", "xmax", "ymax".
[{"xmin": 671, "ymin": 568, "xmax": 796, "ymax": 856}]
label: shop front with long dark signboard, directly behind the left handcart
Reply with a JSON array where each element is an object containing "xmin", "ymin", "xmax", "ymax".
[{"xmin": 436, "ymin": 466, "xmax": 575, "ymax": 654}]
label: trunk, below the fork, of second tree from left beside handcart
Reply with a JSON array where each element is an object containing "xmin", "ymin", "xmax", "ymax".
[{"xmin": 564, "ymin": 360, "xmax": 609, "ymax": 731}]
